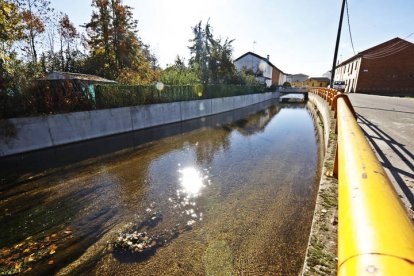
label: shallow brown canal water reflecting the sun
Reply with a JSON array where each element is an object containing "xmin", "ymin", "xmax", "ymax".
[{"xmin": 0, "ymin": 101, "xmax": 321, "ymax": 275}]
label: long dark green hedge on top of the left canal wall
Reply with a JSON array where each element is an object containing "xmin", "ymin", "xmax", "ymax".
[{"xmin": 0, "ymin": 81, "xmax": 265, "ymax": 119}]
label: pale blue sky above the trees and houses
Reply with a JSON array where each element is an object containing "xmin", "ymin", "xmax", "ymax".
[{"xmin": 51, "ymin": 0, "xmax": 414, "ymax": 76}]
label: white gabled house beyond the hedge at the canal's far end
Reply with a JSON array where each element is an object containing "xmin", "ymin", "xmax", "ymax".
[{"xmin": 234, "ymin": 52, "xmax": 286, "ymax": 87}]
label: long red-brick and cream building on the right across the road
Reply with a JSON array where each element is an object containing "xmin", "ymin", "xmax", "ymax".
[{"xmin": 335, "ymin": 37, "xmax": 414, "ymax": 95}]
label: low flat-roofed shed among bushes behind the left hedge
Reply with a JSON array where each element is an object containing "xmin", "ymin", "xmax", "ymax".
[{"xmin": 39, "ymin": 72, "xmax": 116, "ymax": 98}]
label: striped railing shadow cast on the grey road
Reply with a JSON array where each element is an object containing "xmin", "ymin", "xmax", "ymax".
[{"xmin": 357, "ymin": 114, "xmax": 414, "ymax": 210}]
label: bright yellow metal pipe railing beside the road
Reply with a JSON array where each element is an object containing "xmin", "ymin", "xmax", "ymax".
[{"xmin": 311, "ymin": 89, "xmax": 414, "ymax": 275}]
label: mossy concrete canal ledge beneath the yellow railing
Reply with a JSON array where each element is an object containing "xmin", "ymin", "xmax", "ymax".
[{"xmin": 301, "ymin": 93, "xmax": 338, "ymax": 276}]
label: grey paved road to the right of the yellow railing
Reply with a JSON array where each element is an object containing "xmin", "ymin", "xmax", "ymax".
[{"xmin": 348, "ymin": 94, "xmax": 414, "ymax": 216}]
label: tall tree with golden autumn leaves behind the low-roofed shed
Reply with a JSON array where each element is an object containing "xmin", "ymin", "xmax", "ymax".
[{"xmin": 85, "ymin": 0, "xmax": 158, "ymax": 84}]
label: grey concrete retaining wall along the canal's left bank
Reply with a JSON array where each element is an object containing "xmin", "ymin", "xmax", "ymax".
[{"xmin": 0, "ymin": 92, "xmax": 279, "ymax": 156}]
